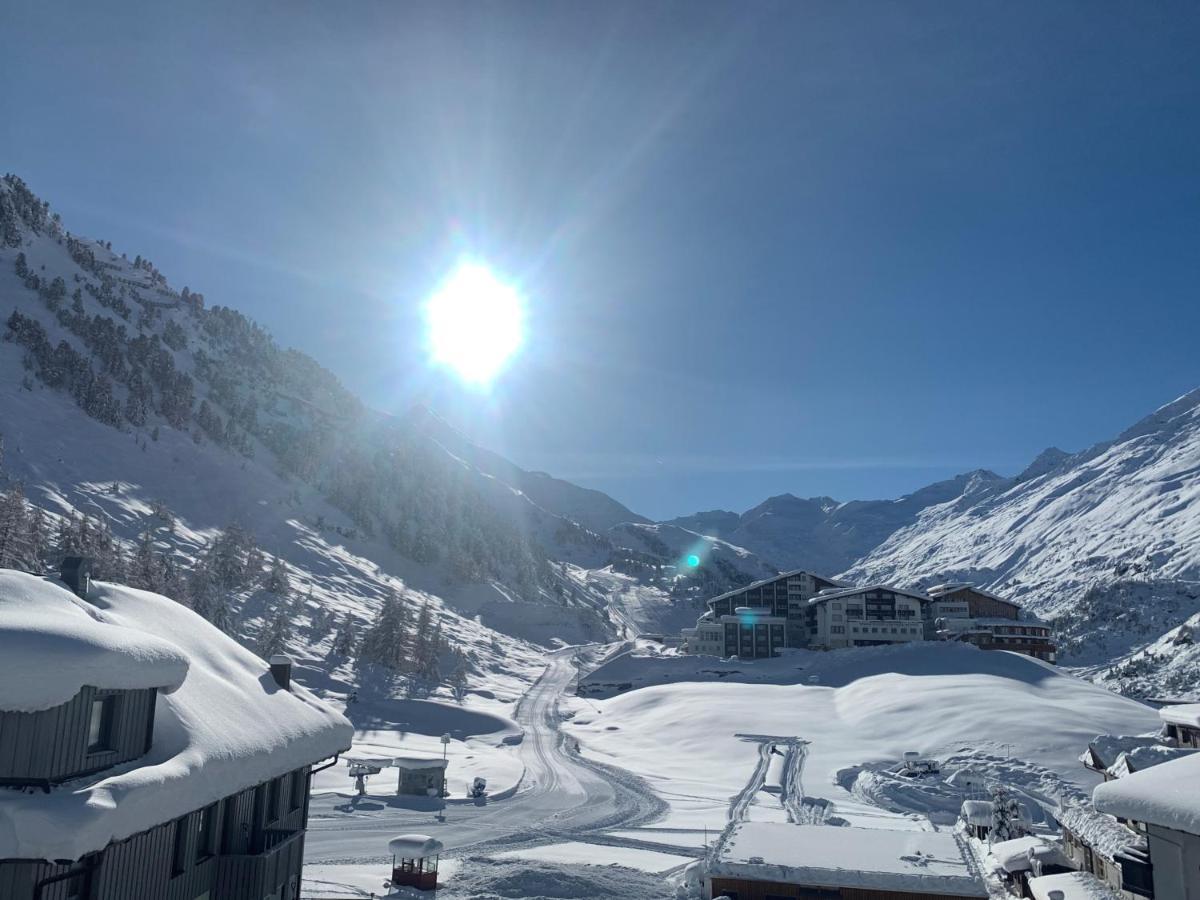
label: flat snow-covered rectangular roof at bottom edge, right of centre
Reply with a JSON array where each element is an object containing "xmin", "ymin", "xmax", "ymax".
[{"xmin": 708, "ymin": 822, "xmax": 988, "ymax": 896}]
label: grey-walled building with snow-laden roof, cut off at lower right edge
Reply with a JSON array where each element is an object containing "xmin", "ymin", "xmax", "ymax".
[{"xmin": 1092, "ymin": 754, "xmax": 1200, "ymax": 900}]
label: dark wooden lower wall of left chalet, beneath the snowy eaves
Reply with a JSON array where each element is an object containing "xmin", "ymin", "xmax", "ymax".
[{"xmin": 0, "ymin": 767, "xmax": 311, "ymax": 900}]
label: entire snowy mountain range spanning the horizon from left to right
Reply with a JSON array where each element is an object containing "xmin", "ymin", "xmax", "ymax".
[{"xmin": 0, "ymin": 176, "xmax": 1200, "ymax": 694}]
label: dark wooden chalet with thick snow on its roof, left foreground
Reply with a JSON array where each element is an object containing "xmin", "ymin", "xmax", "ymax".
[{"xmin": 0, "ymin": 562, "xmax": 353, "ymax": 900}]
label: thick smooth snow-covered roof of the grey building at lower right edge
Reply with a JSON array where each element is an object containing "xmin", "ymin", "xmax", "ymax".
[{"xmin": 1092, "ymin": 754, "xmax": 1200, "ymax": 835}]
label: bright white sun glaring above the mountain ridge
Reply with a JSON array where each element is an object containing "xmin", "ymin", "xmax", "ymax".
[{"xmin": 425, "ymin": 262, "xmax": 524, "ymax": 386}]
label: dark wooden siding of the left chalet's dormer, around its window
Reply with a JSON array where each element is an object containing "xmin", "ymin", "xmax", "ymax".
[{"xmin": 0, "ymin": 686, "xmax": 158, "ymax": 784}]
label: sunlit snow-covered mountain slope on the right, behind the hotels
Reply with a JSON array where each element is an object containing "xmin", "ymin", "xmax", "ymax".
[{"xmin": 841, "ymin": 390, "xmax": 1200, "ymax": 694}]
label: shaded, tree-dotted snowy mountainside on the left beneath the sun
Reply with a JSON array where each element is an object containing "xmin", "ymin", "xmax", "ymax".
[{"xmin": 0, "ymin": 176, "xmax": 769, "ymax": 691}]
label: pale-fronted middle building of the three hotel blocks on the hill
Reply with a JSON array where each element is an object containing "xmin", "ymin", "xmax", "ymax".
[{"xmin": 804, "ymin": 584, "xmax": 929, "ymax": 649}]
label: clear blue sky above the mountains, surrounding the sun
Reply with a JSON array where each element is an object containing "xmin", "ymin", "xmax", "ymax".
[{"xmin": 0, "ymin": 0, "xmax": 1200, "ymax": 517}]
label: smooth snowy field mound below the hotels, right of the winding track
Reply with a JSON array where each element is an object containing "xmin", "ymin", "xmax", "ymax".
[{"xmin": 564, "ymin": 643, "xmax": 1158, "ymax": 832}]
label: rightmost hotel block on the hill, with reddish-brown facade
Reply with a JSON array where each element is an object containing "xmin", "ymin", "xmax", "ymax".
[{"xmin": 923, "ymin": 582, "xmax": 1057, "ymax": 662}]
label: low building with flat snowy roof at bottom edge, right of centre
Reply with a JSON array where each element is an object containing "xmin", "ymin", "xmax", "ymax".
[{"xmin": 702, "ymin": 822, "xmax": 988, "ymax": 900}]
